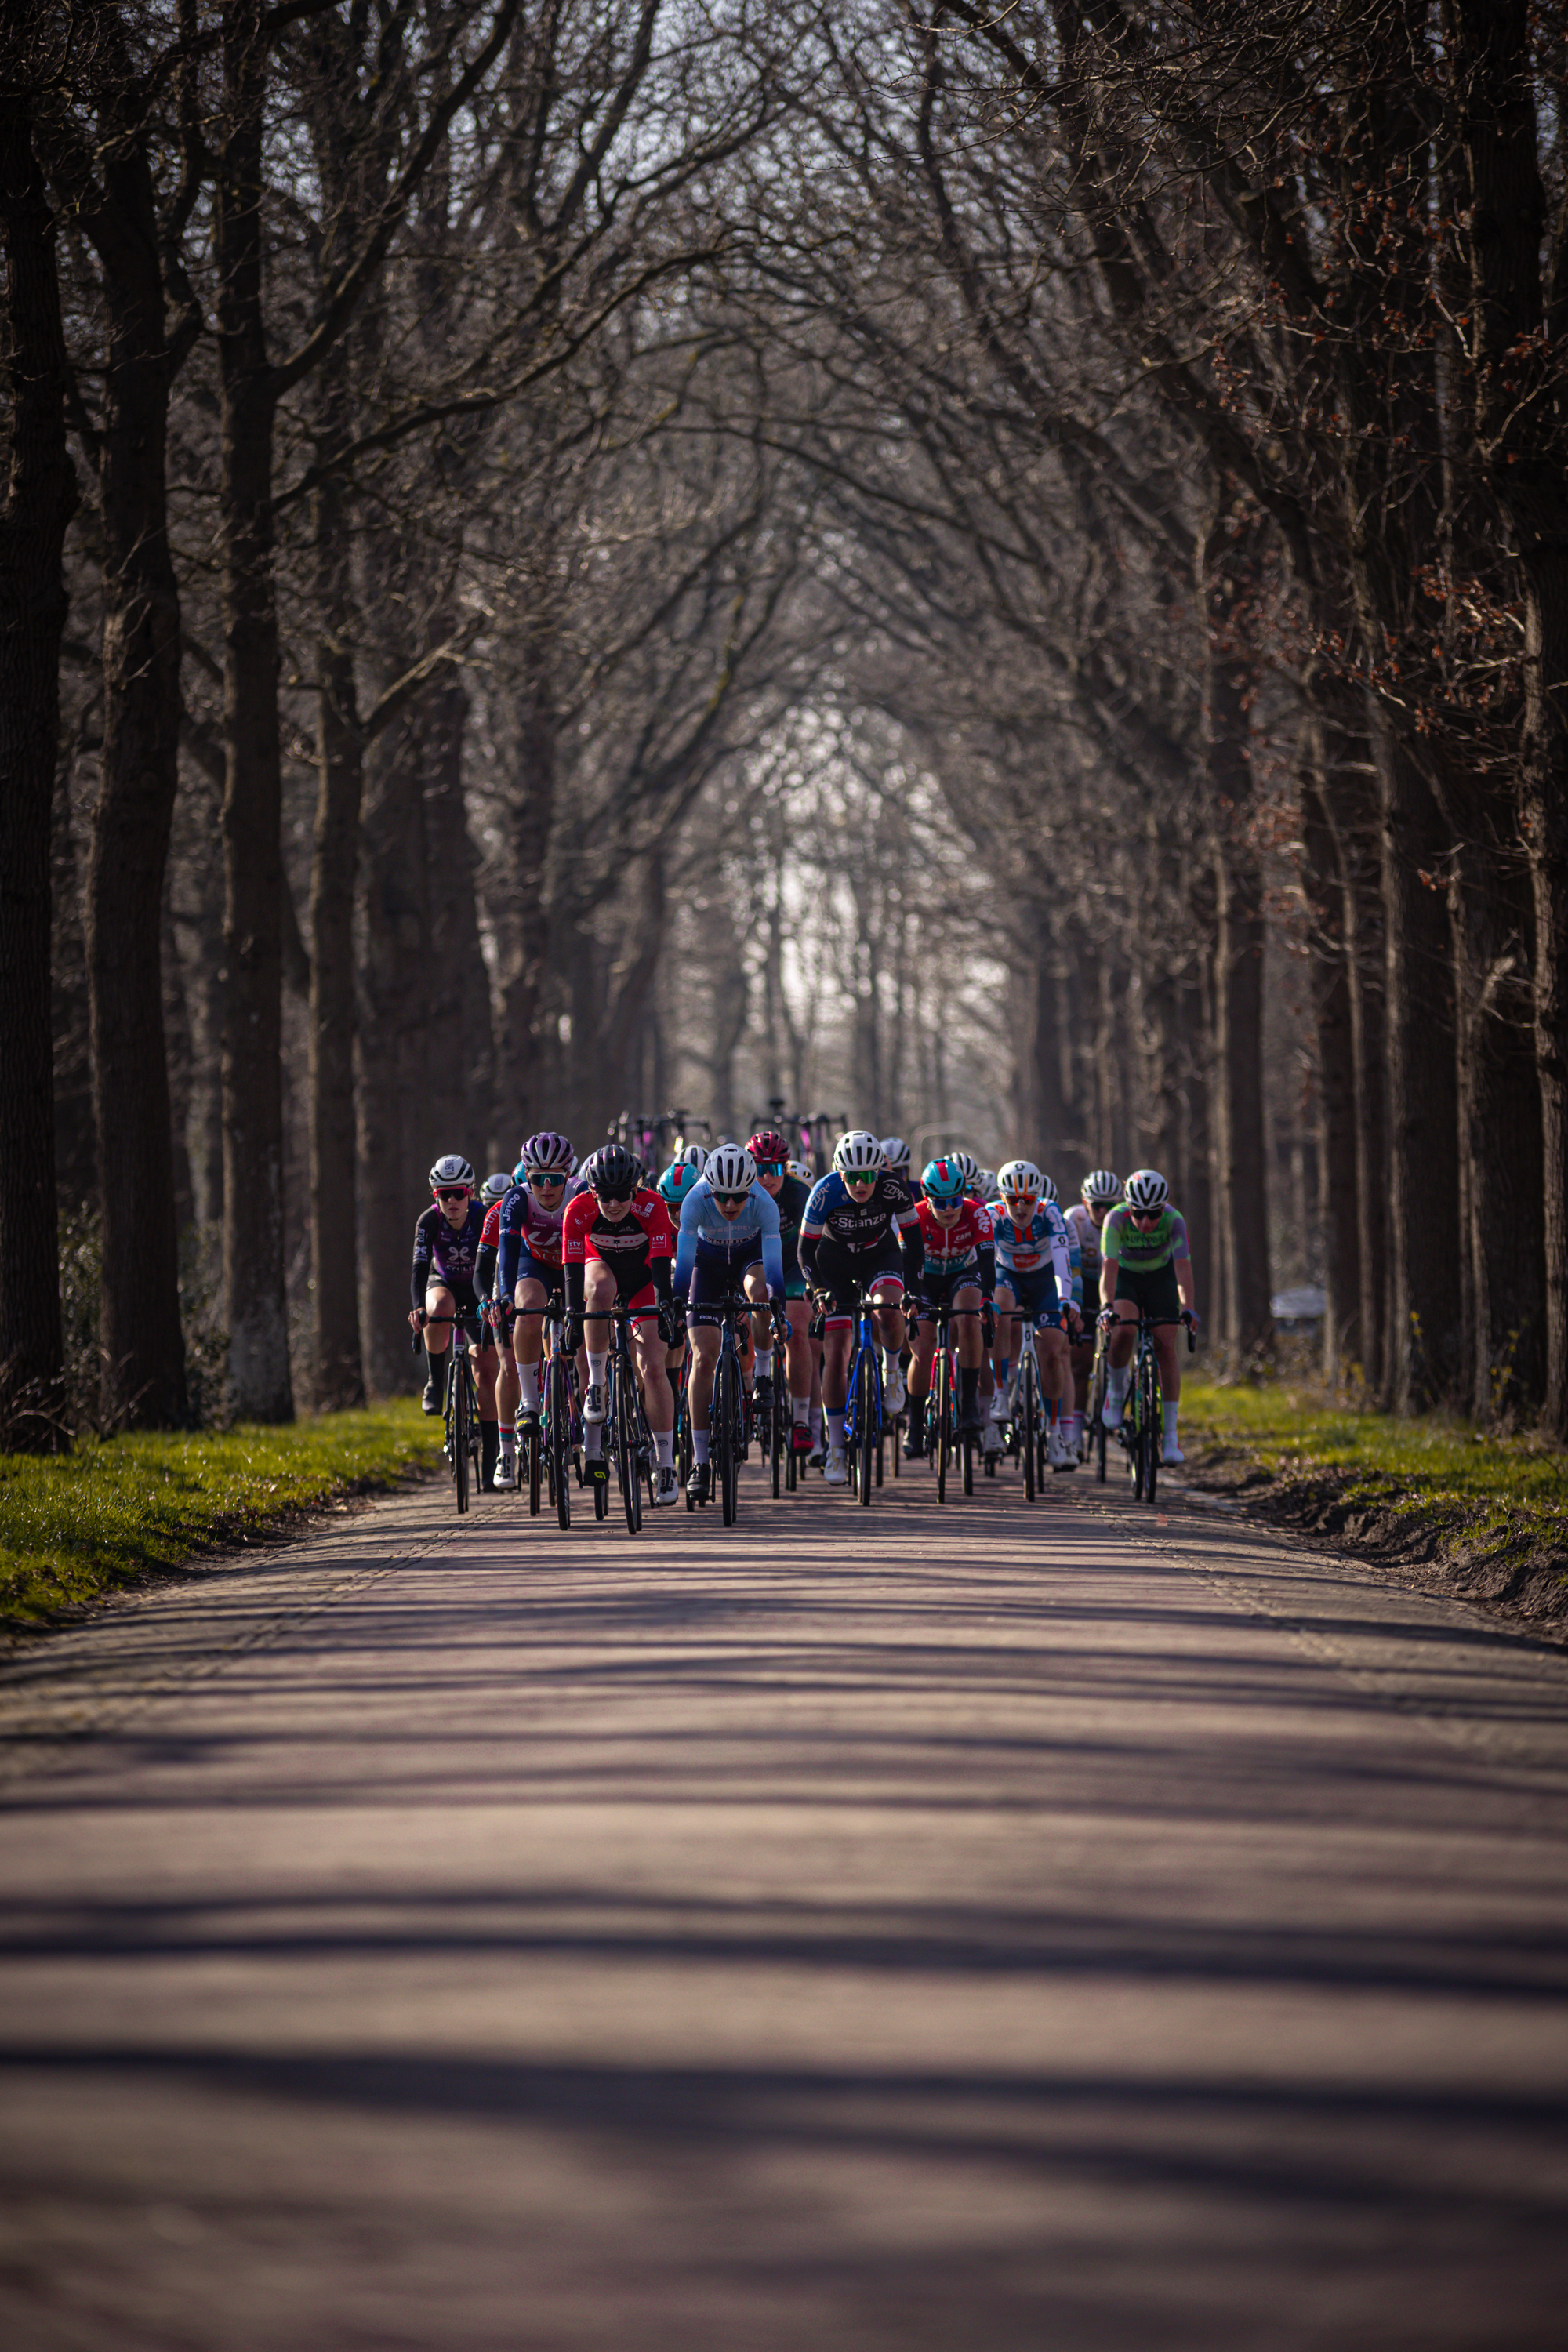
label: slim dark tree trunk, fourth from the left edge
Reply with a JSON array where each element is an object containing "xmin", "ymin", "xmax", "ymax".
[{"xmin": 310, "ymin": 442, "xmax": 365, "ymax": 1411}]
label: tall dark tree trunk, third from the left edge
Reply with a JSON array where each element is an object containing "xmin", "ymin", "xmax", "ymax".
[{"xmin": 214, "ymin": 0, "xmax": 294, "ymax": 1421}]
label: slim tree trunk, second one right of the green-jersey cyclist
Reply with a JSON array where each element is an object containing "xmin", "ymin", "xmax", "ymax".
[{"xmin": 1300, "ymin": 748, "xmax": 1361, "ymax": 1381}]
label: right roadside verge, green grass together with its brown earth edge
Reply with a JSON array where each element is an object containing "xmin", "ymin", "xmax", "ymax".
[{"xmin": 1182, "ymin": 1381, "xmax": 1568, "ymax": 1635}]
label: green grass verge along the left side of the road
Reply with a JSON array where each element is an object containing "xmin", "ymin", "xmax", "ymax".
[{"xmin": 0, "ymin": 1397, "xmax": 433, "ymax": 1628}]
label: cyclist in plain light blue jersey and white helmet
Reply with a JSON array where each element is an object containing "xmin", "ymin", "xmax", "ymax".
[{"xmin": 675, "ymin": 1143, "xmax": 783, "ymax": 1503}]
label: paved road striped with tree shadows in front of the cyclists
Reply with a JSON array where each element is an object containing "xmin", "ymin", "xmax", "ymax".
[{"xmin": 0, "ymin": 1475, "xmax": 1568, "ymax": 2352}]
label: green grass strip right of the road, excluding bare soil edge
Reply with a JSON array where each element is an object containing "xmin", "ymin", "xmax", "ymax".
[{"xmin": 1182, "ymin": 1381, "xmax": 1568, "ymax": 1555}]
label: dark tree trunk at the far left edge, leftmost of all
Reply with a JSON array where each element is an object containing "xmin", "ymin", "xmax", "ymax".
[{"xmin": 0, "ymin": 94, "xmax": 75, "ymax": 1454}]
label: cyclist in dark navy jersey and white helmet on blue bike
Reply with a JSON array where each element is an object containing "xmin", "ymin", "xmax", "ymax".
[{"xmin": 799, "ymin": 1127, "xmax": 926, "ymax": 1486}]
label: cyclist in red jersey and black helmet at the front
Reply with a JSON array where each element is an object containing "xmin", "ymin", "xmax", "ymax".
[{"xmin": 562, "ymin": 1143, "xmax": 680, "ymax": 1503}]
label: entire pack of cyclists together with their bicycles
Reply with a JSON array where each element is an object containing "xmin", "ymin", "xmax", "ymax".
[{"xmin": 409, "ymin": 1122, "xmax": 1199, "ymax": 1529}]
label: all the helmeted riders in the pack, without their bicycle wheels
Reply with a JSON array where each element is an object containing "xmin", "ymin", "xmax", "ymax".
[{"xmin": 409, "ymin": 1127, "xmax": 1196, "ymax": 1505}]
